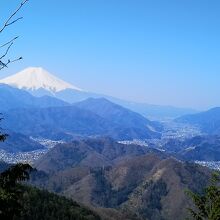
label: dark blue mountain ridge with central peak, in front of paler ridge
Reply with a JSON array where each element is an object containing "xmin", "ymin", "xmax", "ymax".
[{"xmin": 2, "ymin": 99, "xmax": 162, "ymax": 140}]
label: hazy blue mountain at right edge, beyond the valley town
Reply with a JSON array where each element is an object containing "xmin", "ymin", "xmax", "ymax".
[{"xmin": 175, "ymin": 107, "xmax": 220, "ymax": 135}]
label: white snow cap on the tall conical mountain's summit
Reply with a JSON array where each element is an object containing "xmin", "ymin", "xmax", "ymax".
[{"xmin": 0, "ymin": 67, "xmax": 82, "ymax": 93}]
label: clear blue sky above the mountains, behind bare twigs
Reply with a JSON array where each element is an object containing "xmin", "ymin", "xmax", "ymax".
[{"xmin": 0, "ymin": 0, "xmax": 220, "ymax": 109}]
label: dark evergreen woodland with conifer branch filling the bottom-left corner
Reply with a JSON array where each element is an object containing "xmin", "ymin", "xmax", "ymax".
[{"xmin": 0, "ymin": 164, "xmax": 100, "ymax": 220}]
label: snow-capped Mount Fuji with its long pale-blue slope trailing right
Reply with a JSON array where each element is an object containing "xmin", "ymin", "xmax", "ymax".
[{"xmin": 0, "ymin": 67, "xmax": 196, "ymax": 120}]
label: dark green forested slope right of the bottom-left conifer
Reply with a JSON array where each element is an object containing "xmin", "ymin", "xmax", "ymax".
[{"xmin": 15, "ymin": 186, "xmax": 100, "ymax": 220}]
